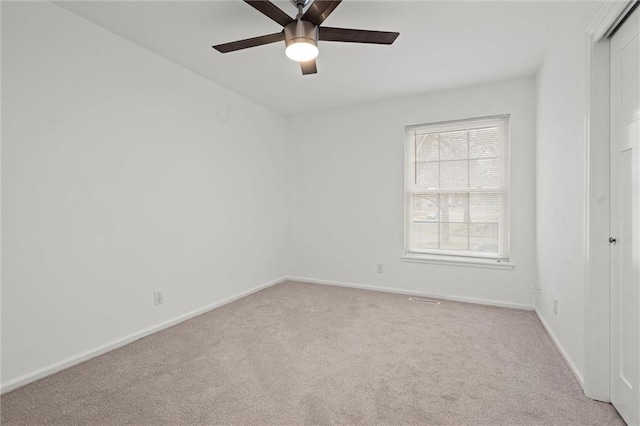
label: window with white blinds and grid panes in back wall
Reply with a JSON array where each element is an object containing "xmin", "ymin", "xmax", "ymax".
[{"xmin": 405, "ymin": 115, "xmax": 509, "ymax": 262}]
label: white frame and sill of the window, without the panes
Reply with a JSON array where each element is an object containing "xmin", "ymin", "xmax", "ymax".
[{"xmin": 402, "ymin": 114, "xmax": 513, "ymax": 269}]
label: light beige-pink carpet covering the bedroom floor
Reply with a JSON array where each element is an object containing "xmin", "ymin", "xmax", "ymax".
[{"xmin": 2, "ymin": 282, "xmax": 623, "ymax": 425}]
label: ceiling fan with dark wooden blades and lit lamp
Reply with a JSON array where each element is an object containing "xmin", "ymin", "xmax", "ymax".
[{"xmin": 213, "ymin": 0, "xmax": 400, "ymax": 75}]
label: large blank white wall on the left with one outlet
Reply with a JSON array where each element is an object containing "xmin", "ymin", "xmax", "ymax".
[{"xmin": 2, "ymin": 2, "xmax": 287, "ymax": 390}]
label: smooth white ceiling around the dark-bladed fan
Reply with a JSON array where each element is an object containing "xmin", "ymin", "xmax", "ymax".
[{"xmin": 57, "ymin": 0, "xmax": 588, "ymax": 116}]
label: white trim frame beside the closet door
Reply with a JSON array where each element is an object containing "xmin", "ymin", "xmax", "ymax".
[{"xmin": 583, "ymin": 0, "xmax": 639, "ymax": 402}]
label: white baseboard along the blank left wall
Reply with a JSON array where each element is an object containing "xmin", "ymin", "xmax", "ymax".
[{"xmin": 0, "ymin": 277, "xmax": 286, "ymax": 394}]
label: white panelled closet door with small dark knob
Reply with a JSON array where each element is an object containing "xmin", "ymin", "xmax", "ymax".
[{"xmin": 611, "ymin": 4, "xmax": 640, "ymax": 425}]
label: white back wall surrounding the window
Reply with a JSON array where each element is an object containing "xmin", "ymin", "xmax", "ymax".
[{"xmin": 287, "ymin": 79, "xmax": 536, "ymax": 306}]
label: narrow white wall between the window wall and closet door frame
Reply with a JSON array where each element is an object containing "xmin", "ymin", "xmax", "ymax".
[{"xmin": 536, "ymin": 3, "xmax": 608, "ymax": 379}]
